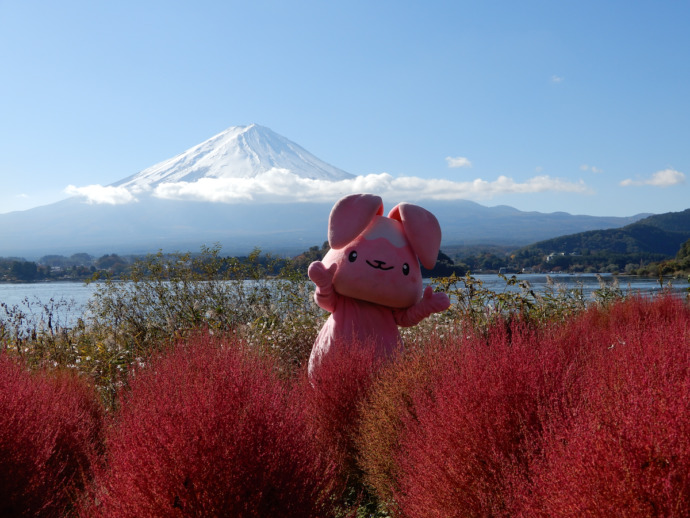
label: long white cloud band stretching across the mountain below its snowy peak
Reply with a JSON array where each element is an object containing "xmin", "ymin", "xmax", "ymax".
[{"xmin": 66, "ymin": 168, "xmax": 591, "ymax": 204}]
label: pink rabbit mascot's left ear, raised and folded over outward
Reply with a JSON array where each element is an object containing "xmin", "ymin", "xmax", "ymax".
[{"xmin": 328, "ymin": 194, "xmax": 382, "ymax": 251}]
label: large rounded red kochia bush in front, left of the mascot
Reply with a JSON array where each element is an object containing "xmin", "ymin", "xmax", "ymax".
[{"xmin": 82, "ymin": 336, "xmax": 330, "ymax": 518}]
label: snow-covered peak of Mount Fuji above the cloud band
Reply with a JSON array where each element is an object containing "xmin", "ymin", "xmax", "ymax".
[{"xmin": 112, "ymin": 124, "xmax": 355, "ymax": 192}]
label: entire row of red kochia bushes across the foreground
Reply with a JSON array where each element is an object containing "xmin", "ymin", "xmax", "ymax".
[{"xmin": 0, "ymin": 296, "xmax": 690, "ymax": 518}]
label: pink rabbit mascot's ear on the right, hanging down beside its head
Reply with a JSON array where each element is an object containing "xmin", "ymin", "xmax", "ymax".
[{"xmin": 388, "ymin": 203, "xmax": 441, "ymax": 270}]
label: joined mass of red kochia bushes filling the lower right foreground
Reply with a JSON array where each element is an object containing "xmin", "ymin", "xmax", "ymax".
[{"xmin": 361, "ymin": 297, "xmax": 690, "ymax": 517}]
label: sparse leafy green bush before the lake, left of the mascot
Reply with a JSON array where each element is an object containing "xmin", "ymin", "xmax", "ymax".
[{"xmin": 87, "ymin": 246, "xmax": 320, "ymax": 380}]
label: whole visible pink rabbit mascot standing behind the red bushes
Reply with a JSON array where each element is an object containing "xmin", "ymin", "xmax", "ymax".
[{"xmin": 309, "ymin": 194, "xmax": 450, "ymax": 373}]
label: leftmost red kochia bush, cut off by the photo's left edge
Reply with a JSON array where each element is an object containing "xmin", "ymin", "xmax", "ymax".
[{"xmin": 0, "ymin": 354, "xmax": 103, "ymax": 517}]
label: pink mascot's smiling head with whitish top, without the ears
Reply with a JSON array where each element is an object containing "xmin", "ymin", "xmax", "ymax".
[{"xmin": 323, "ymin": 215, "xmax": 422, "ymax": 308}]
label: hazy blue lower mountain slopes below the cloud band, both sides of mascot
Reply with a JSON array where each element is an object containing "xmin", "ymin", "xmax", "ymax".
[{"xmin": 0, "ymin": 198, "xmax": 652, "ymax": 257}]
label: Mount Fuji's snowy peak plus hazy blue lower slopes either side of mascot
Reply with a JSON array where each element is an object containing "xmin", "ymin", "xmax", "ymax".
[{"xmin": 0, "ymin": 125, "xmax": 648, "ymax": 258}]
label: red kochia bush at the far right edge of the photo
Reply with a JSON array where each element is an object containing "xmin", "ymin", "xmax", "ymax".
[{"xmin": 524, "ymin": 297, "xmax": 690, "ymax": 517}]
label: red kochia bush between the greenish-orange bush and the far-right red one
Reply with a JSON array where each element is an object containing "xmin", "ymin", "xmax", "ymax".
[{"xmin": 394, "ymin": 320, "xmax": 582, "ymax": 518}]
